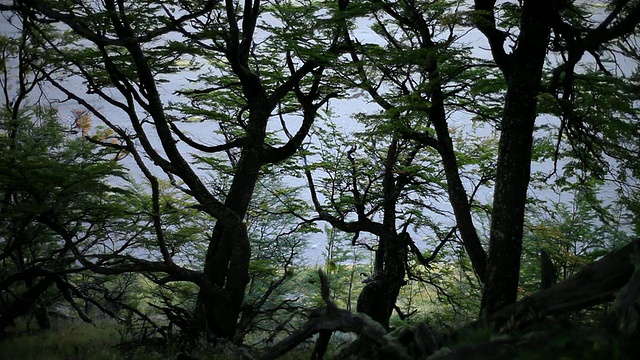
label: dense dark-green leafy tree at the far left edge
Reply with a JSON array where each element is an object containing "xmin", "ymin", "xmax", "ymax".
[{"xmin": 0, "ymin": 29, "xmax": 130, "ymax": 332}]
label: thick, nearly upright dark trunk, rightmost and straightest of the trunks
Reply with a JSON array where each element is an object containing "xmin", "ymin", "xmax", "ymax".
[{"xmin": 482, "ymin": 1, "xmax": 551, "ymax": 315}]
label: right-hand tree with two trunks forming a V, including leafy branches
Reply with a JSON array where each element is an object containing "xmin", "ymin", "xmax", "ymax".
[{"xmin": 330, "ymin": 0, "xmax": 639, "ymax": 320}]
